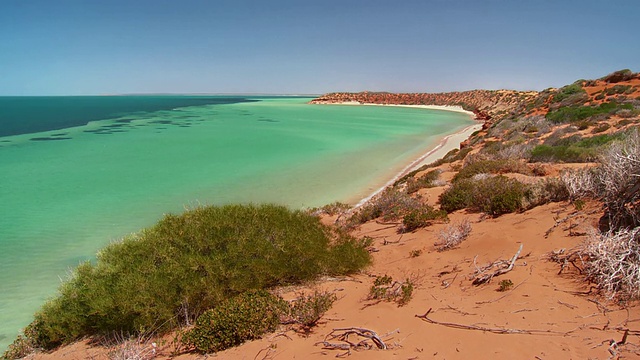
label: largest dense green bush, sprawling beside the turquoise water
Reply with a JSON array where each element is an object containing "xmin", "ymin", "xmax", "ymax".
[{"xmin": 17, "ymin": 205, "xmax": 370, "ymax": 349}]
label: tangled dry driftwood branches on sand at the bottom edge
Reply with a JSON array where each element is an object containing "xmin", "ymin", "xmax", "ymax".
[{"xmin": 316, "ymin": 327, "xmax": 387, "ymax": 357}]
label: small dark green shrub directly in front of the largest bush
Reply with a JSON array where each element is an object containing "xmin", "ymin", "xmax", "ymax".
[{"xmin": 185, "ymin": 290, "xmax": 288, "ymax": 353}]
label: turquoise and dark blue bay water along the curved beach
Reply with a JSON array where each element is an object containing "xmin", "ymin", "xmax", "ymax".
[{"xmin": 0, "ymin": 96, "xmax": 472, "ymax": 349}]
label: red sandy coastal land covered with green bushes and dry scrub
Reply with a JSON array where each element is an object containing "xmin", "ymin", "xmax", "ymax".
[{"xmin": 5, "ymin": 70, "xmax": 640, "ymax": 359}]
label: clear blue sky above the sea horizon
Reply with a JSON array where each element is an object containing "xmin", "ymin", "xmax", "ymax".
[{"xmin": 0, "ymin": 0, "xmax": 640, "ymax": 95}]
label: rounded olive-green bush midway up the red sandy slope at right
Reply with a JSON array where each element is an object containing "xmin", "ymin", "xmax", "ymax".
[{"xmin": 439, "ymin": 176, "xmax": 526, "ymax": 216}]
